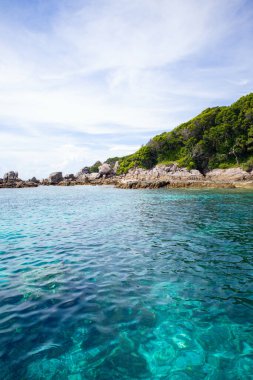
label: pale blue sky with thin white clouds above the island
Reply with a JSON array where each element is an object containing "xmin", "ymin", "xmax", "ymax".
[{"xmin": 0, "ymin": 0, "xmax": 253, "ymax": 179}]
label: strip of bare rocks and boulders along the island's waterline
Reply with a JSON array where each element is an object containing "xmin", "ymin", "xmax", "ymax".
[{"xmin": 0, "ymin": 163, "xmax": 253, "ymax": 189}]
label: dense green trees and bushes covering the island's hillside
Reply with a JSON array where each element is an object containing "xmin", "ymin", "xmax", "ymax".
[{"xmin": 112, "ymin": 93, "xmax": 253, "ymax": 174}]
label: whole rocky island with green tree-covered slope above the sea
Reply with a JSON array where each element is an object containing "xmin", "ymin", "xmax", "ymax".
[{"xmin": 0, "ymin": 93, "xmax": 253, "ymax": 189}]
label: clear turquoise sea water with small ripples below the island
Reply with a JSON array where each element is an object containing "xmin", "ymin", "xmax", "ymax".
[{"xmin": 0, "ymin": 186, "xmax": 253, "ymax": 380}]
